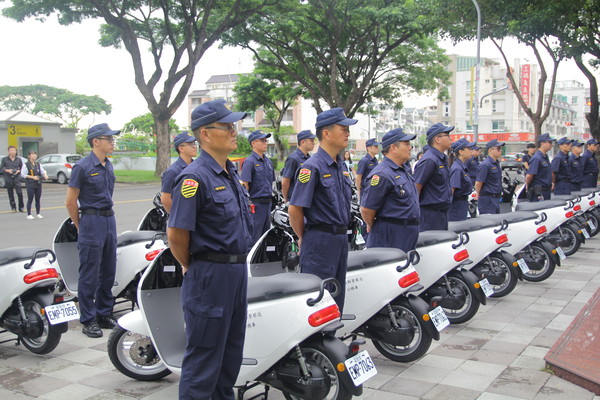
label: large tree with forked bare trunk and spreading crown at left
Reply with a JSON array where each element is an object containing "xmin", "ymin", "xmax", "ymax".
[{"xmin": 3, "ymin": 0, "xmax": 277, "ymax": 176}]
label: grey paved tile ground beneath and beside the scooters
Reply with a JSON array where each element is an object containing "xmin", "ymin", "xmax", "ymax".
[{"xmin": 0, "ymin": 237, "xmax": 600, "ymax": 400}]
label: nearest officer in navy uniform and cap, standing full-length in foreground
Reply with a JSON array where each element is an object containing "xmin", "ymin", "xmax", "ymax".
[{"xmin": 167, "ymin": 100, "xmax": 252, "ymax": 400}]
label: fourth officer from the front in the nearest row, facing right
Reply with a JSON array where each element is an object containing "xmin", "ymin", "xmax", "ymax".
[{"xmin": 414, "ymin": 123, "xmax": 454, "ymax": 232}]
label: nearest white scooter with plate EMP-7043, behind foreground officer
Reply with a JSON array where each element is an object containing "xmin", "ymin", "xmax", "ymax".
[{"xmin": 108, "ymin": 249, "xmax": 376, "ymax": 400}]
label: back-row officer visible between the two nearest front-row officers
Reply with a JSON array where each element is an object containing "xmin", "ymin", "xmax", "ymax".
[{"xmin": 242, "ymin": 130, "xmax": 275, "ymax": 243}]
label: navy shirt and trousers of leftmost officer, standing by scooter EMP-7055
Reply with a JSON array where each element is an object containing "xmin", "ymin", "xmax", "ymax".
[{"xmin": 69, "ymin": 152, "xmax": 117, "ymax": 325}]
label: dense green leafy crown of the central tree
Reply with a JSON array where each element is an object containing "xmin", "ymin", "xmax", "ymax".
[{"xmin": 226, "ymin": 0, "xmax": 448, "ymax": 116}]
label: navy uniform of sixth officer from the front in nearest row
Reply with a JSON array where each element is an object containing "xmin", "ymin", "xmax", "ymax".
[{"xmin": 477, "ymin": 156, "xmax": 502, "ymax": 214}]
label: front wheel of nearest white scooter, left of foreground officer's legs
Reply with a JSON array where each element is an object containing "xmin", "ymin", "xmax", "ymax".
[{"xmin": 108, "ymin": 325, "xmax": 171, "ymax": 381}]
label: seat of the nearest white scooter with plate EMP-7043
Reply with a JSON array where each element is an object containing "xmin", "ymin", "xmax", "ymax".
[{"xmin": 248, "ymin": 274, "xmax": 321, "ymax": 303}]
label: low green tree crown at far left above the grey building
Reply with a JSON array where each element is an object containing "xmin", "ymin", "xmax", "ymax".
[{"xmin": 0, "ymin": 85, "xmax": 111, "ymax": 128}]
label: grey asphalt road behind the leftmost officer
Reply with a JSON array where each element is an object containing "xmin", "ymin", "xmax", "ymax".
[{"xmin": 0, "ymin": 182, "xmax": 160, "ymax": 249}]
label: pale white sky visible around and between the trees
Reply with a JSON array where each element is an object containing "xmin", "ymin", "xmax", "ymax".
[{"xmin": 0, "ymin": 12, "xmax": 589, "ymax": 129}]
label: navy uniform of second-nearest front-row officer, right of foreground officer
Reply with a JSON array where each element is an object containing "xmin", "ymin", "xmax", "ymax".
[{"xmin": 290, "ymin": 145, "xmax": 352, "ymax": 310}]
